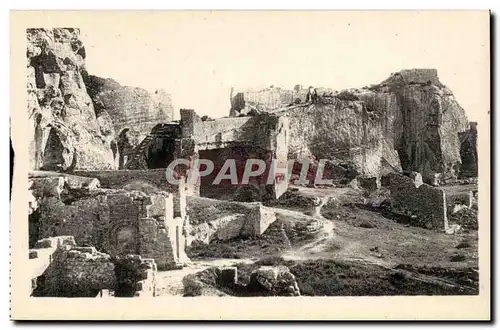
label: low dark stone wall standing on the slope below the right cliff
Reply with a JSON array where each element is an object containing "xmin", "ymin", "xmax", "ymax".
[{"xmin": 382, "ymin": 173, "xmax": 448, "ymax": 230}]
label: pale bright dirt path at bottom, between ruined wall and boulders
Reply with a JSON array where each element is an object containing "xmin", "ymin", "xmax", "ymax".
[{"xmin": 156, "ymin": 259, "xmax": 253, "ymax": 296}]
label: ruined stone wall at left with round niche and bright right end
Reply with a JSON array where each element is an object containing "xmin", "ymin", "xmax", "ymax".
[{"xmin": 30, "ymin": 177, "xmax": 186, "ymax": 268}]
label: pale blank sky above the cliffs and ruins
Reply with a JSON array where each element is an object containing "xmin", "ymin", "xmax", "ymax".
[{"xmin": 76, "ymin": 11, "xmax": 489, "ymax": 120}]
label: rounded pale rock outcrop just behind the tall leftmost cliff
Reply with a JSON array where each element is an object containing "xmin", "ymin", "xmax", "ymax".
[{"xmin": 85, "ymin": 75, "xmax": 174, "ymax": 151}]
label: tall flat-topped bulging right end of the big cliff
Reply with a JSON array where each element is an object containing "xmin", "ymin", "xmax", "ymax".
[{"xmin": 377, "ymin": 69, "xmax": 468, "ymax": 182}]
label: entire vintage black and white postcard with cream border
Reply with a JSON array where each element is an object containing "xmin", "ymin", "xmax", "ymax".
[{"xmin": 11, "ymin": 11, "xmax": 490, "ymax": 319}]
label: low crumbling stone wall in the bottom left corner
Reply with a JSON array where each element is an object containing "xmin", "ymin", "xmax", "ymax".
[{"xmin": 29, "ymin": 236, "xmax": 157, "ymax": 298}]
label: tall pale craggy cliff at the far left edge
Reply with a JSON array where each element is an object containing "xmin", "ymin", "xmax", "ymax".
[{"xmin": 26, "ymin": 28, "xmax": 116, "ymax": 171}]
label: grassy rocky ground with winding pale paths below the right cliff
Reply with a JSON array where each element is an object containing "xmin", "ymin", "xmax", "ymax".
[{"xmin": 170, "ymin": 186, "xmax": 478, "ymax": 296}]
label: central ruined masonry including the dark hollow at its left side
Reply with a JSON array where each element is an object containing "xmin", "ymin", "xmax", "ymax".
[{"xmin": 122, "ymin": 109, "xmax": 289, "ymax": 198}]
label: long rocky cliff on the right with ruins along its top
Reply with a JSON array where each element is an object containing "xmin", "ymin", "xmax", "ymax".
[{"xmin": 231, "ymin": 69, "xmax": 475, "ymax": 182}]
